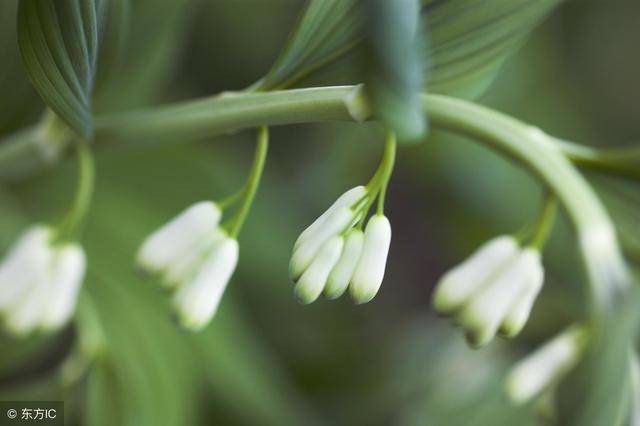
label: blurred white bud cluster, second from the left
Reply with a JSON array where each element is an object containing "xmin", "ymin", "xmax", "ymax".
[{"xmin": 137, "ymin": 201, "xmax": 238, "ymax": 330}]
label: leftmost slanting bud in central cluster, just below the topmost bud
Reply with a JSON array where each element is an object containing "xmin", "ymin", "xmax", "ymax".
[{"xmin": 289, "ymin": 207, "xmax": 356, "ymax": 281}]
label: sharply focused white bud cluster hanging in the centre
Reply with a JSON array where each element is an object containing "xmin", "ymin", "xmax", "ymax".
[{"xmin": 289, "ymin": 186, "xmax": 391, "ymax": 303}]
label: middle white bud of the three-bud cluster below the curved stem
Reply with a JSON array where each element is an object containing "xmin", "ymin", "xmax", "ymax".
[{"xmin": 459, "ymin": 249, "xmax": 540, "ymax": 347}]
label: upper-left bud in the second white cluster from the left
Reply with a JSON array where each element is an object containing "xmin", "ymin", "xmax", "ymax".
[{"xmin": 137, "ymin": 201, "xmax": 222, "ymax": 273}]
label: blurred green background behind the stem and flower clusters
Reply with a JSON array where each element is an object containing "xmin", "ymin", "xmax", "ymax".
[{"xmin": 0, "ymin": 0, "xmax": 640, "ymax": 426}]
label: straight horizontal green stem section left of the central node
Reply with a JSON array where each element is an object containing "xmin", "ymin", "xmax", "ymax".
[{"xmin": 95, "ymin": 86, "xmax": 369, "ymax": 147}]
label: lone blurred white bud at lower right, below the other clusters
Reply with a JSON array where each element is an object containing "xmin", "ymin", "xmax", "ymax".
[{"xmin": 505, "ymin": 326, "xmax": 587, "ymax": 405}]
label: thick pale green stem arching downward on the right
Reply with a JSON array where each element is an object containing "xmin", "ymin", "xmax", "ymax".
[{"xmin": 422, "ymin": 95, "xmax": 630, "ymax": 316}]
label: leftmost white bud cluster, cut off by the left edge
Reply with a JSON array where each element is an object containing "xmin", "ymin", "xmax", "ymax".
[{"xmin": 0, "ymin": 225, "xmax": 86, "ymax": 336}]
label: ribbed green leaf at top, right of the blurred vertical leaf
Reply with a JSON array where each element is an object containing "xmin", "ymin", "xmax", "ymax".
[{"xmin": 422, "ymin": 0, "xmax": 560, "ymax": 98}]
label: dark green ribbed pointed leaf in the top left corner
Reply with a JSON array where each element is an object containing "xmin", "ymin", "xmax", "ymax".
[{"xmin": 18, "ymin": 0, "xmax": 101, "ymax": 138}]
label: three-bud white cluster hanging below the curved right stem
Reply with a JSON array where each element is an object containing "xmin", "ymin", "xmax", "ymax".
[{"xmin": 434, "ymin": 236, "xmax": 544, "ymax": 347}]
